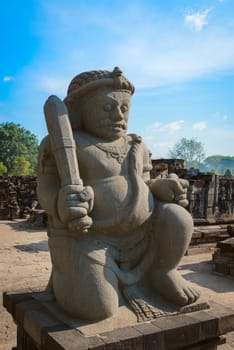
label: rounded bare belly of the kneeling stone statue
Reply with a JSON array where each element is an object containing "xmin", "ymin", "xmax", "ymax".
[{"xmin": 90, "ymin": 176, "xmax": 154, "ymax": 235}]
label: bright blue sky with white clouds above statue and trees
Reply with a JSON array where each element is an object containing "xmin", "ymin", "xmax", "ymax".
[{"xmin": 0, "ymin": 0, "xmax": 234, "ymax": 158}]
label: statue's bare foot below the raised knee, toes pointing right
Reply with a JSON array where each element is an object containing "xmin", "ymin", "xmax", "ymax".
[{"xmin": 153, "ymin": 270, "xmax": 200, "ymax": 306}]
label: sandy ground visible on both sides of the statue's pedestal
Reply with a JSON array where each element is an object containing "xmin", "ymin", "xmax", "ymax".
[{"xmin": 0, "ymin": 220, "xmax": 234, "ymax": 350}]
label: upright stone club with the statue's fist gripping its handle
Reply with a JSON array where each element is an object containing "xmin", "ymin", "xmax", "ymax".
[{"xmin": 44, "ymin": 96, "xmax": 94, "ymax": 231}]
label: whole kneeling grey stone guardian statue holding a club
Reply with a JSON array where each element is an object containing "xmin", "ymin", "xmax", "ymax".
[{"xmin": 38, "ymin": 68, "xmax": 199, "ymax": 320}]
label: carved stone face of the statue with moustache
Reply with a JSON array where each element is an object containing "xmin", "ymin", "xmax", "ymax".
[{"xmin": 82, "ymin": 89, "xmax": 131, "ymax": 140}]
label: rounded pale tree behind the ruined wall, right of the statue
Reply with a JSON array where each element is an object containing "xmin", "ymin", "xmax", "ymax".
[{"xmin": 169, "ymin": 138, "xmax": 205, "ymax": 168}]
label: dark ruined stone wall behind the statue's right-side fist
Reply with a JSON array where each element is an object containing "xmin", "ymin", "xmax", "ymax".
[{"xmin": 151, "ymin": 159, "xmax": 234, "ymax": 222}]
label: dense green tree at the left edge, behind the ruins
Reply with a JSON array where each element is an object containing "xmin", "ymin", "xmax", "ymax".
[{"xmin": 0, "ymin": 123, "xmax": 38, "ymax": 175}]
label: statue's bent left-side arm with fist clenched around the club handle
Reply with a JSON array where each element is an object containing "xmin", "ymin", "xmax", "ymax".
[{"xmin": 37, "ymin": 136, "xmax": 94, "ymax": 231}]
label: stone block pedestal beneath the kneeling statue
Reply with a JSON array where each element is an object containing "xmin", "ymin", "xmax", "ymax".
[{"xmin": 3, "ymin": 292, "xmax": 234, "ymax": 350}]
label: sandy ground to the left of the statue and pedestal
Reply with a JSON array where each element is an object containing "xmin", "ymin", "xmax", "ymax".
[{"xmin": 0, "ymin": 221, "xmax": 51, "ymax": 350}]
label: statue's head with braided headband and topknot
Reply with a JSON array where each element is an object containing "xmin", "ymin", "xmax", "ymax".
[{"xmin": 64, "ymin": 67, "xmax": 134, "ymax": 140}]
